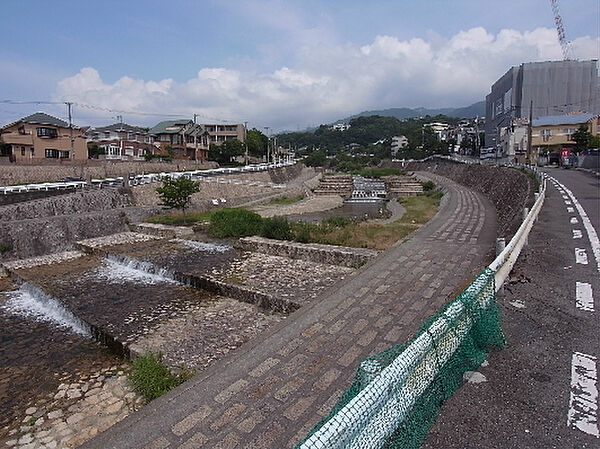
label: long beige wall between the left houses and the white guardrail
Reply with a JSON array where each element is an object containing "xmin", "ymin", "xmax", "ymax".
[{"xmin": 0, "ymin": 160, "xmax": 218, "ymax": 186}]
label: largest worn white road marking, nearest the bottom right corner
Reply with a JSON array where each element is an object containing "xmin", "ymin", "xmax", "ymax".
[{"xmin": 567, "ymin": 352, "xmax": 600, "ymax": 438}]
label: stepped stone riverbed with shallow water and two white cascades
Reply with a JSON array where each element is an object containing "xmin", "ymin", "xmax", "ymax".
[{"xmin": 0, "ymin": 228, "xmax": 364, "ymax": 448}]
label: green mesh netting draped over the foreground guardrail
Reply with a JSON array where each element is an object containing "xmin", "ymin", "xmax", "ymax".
[{"xmin": 296, "ymin": 268, "xmax": 505, "ymax": 449}]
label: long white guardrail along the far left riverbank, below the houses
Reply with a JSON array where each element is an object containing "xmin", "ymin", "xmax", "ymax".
[{"xmin": 0, "ymin": 161, "xmax": 296, "ymax": 195}]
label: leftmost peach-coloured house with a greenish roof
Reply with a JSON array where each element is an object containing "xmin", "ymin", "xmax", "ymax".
[{"xmin": 0, "ymin": 112, "xmax": 88, "ymax": 163}]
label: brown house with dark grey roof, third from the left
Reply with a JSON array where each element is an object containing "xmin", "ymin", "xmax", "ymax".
[{"xmin": 148, "ymin": 120, "xmax": 210, "ymax": 161}]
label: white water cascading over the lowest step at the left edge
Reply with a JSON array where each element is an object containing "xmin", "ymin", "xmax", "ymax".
[{"xmin": 0, "ymin": 282, "xmax": 91, "ymax": 337}]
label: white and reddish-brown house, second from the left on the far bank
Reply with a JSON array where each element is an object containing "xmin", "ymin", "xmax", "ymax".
[{"xmin": 87, "ymin": 123, "xmax": 156, "ymax": 160}]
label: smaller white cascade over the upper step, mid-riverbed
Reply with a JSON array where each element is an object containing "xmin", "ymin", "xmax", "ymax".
[{"xmin": 96, "ymin": 254, "xmax": 177, "ymax": 285}]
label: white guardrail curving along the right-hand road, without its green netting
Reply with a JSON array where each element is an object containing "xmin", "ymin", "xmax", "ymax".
[{"xmin": 299, "ymin": 158, "xmax": 546, "ymax": 449}]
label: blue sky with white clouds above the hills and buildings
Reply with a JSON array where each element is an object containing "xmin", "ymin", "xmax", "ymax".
[{"xmin": 0, "ymin": 0, "xmax": 600, "ymax": 132}]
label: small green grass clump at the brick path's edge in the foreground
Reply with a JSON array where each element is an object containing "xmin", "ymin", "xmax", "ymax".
[{"xmin": 129, "ymin": 353, "xmax": 193, "ymax": 402}]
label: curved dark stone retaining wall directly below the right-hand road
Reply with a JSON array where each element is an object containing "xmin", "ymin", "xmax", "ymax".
[{"xmin": 406, "ymin": 159, "xmax": 534, "ymax": 238}]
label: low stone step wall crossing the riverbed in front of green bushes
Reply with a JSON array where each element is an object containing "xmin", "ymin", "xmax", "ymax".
[{"xmin": 236, "ymin": 237, "xmax": 379, "ymax": 268}]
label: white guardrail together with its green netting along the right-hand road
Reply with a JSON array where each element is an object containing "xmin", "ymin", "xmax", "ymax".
[{"xmin": 296, "ymin": 158, "xmax": 546, "ymax": 449}]
